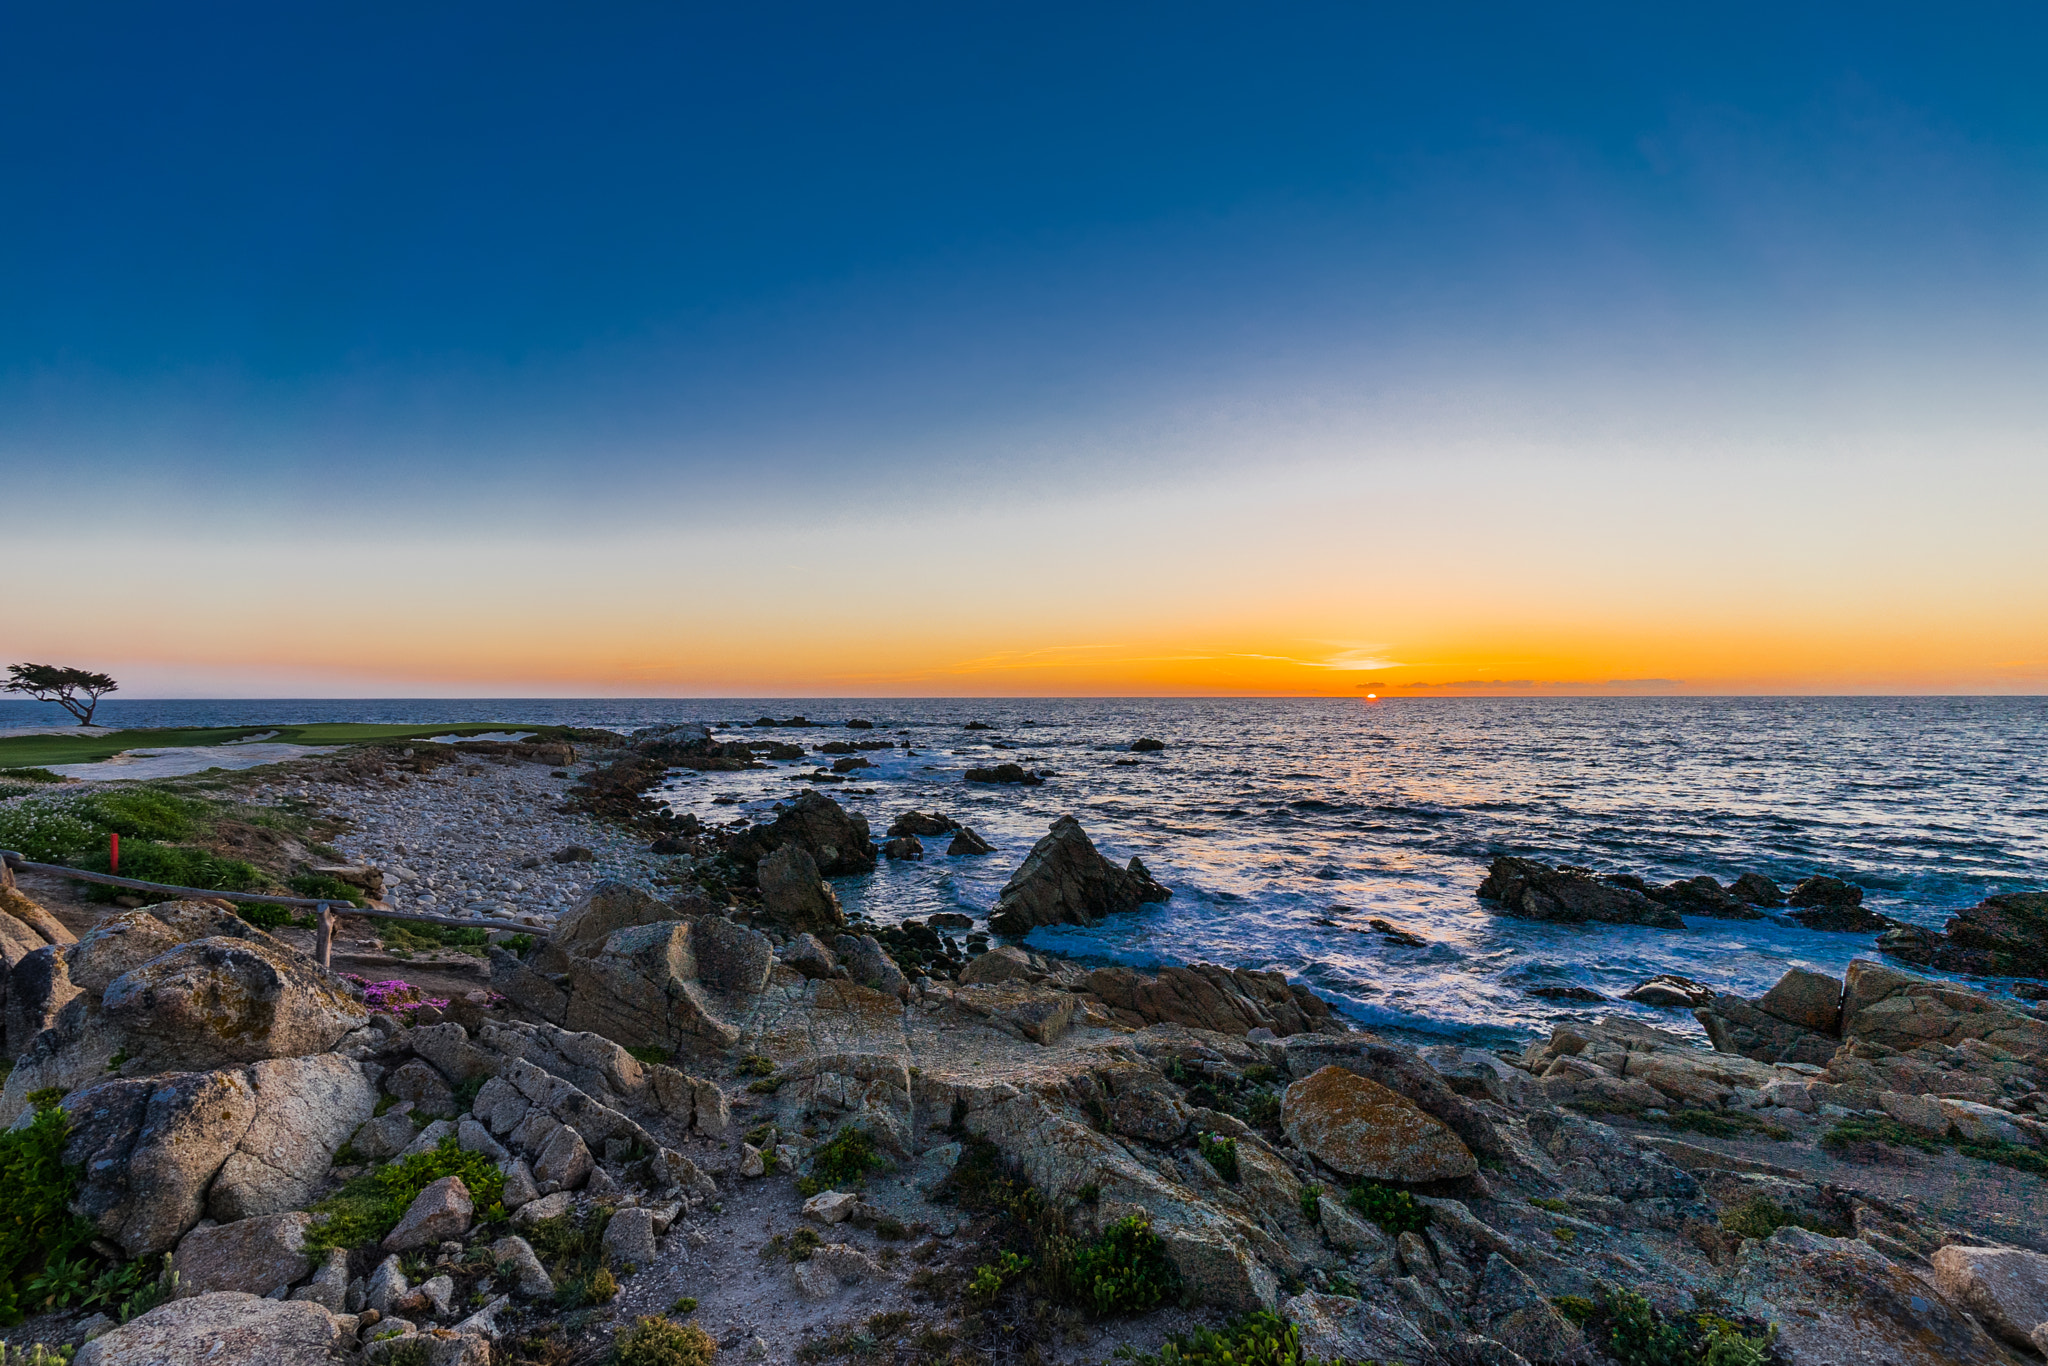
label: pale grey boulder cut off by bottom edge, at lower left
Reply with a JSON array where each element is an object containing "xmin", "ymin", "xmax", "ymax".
[{"xmin": 72, "ymin": 1290, "xmax": 354, "ymax": 1366}]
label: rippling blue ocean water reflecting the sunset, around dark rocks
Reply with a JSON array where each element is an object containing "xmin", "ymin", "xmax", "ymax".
[{"xmin": 0, "ymin": 698, "xmax": 2048, "ymax": 1042}]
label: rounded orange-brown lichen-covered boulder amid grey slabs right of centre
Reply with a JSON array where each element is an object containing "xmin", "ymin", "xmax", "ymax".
[{"xmin": 1280, "ymin": 1067, "xmax": 1479, "ymax": 1182}]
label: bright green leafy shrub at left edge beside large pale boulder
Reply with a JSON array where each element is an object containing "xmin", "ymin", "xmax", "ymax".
[{"xmin": 0, "ymin": 1092, "xmax": 94, "ymax": 1323}]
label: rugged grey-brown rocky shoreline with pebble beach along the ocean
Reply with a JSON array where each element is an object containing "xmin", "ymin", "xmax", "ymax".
[{"xmin": 0, "ymin": 733, "xmax": 2048, "ymax": 1366}]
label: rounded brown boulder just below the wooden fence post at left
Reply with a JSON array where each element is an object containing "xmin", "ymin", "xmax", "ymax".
[{"xmin": 100, "ymin": 938, "xmax": 369, "ymax": 1071}]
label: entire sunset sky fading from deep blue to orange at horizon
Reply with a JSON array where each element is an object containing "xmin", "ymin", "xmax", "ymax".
[{"xmin": 0, "ymin": 0, "xmax": 2048, "ymax": 696}]
